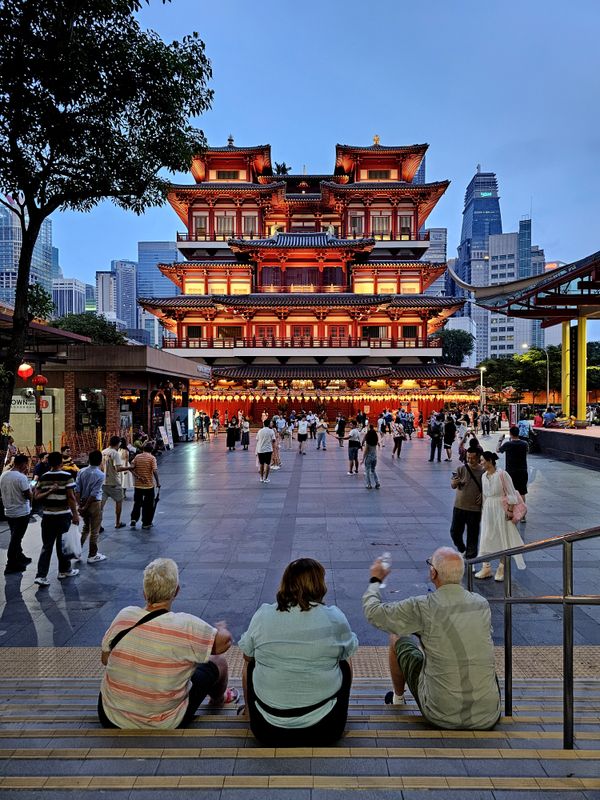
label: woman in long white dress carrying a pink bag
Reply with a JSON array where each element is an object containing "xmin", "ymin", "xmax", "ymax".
[{"xmin": 475, "ymin": 451, "xmax": 525, "ymax": 581}]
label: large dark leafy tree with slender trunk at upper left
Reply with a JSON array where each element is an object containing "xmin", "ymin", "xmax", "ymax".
[{"xmin": 0, "ymin": 0, "xmax": 212, "ymax": 419}]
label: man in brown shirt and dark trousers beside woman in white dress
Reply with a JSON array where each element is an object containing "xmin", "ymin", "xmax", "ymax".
[{"xmin": 450, "ymin": 447, "xmax": 485, "ymax": 559}]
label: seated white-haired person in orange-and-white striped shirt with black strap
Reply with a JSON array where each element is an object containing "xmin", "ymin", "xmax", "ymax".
[{"xmin": 98, "ymin": 558, "xmax": 238, "ymax": 728}]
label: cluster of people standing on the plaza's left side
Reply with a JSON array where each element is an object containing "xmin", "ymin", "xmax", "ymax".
[{"xmin": 0, "ymin": 436, "xmax": 160, "ymax": 586}]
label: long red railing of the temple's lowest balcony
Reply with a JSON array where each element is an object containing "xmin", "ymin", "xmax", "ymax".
[{"xmin": 163, "ymin": 336, "xmax": 442, "ymax": 350}]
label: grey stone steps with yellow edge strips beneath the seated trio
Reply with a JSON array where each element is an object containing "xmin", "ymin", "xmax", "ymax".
[{"xmin": 0, "ymin": 678, "xmax": 600, "ymax": 800}]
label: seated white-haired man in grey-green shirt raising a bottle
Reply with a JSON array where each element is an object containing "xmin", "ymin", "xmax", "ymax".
[{"xmin": 362, "ymin": 547, "xmax": 500, "ymax": 730}]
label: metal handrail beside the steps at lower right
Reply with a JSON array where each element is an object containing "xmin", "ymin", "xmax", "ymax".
[{"xmin": 466, "ymin": 526, "xmax": 600, "ymax": 750}]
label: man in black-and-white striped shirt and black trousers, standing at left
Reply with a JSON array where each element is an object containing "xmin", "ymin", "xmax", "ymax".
[{"xmin": 34, "ymin": 453, "xmax": 79, "ymax": 586}]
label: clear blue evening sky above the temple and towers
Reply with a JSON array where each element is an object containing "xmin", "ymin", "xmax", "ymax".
[{"xmin": 54, "ymin": 0, "xmax": 600, "ymax": 332}]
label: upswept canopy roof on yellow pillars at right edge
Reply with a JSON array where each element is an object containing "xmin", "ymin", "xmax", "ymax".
[{"xmin": 449, "ymin": 251, "xmax": 600, "ymax": 419}]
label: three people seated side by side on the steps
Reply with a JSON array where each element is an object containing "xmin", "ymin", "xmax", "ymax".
[{"xmin": 98, "ymin": 552, "xmax": 501, "ymax": 747}]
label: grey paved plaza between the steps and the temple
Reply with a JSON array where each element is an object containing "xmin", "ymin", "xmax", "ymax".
[{"xmin": 0, "ymin": 434, "xmax": 600, "ymax": 647}]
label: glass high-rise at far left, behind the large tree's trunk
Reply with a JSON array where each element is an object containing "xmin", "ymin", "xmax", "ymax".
[{"xmin": 0, "ymin": 206, "xmax": 52, "ymax": 303}]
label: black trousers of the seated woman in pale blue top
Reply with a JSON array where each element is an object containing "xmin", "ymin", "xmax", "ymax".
[{"xmin": 246, "ymin": 661, "xmax": 352, "ymax": 747}]
